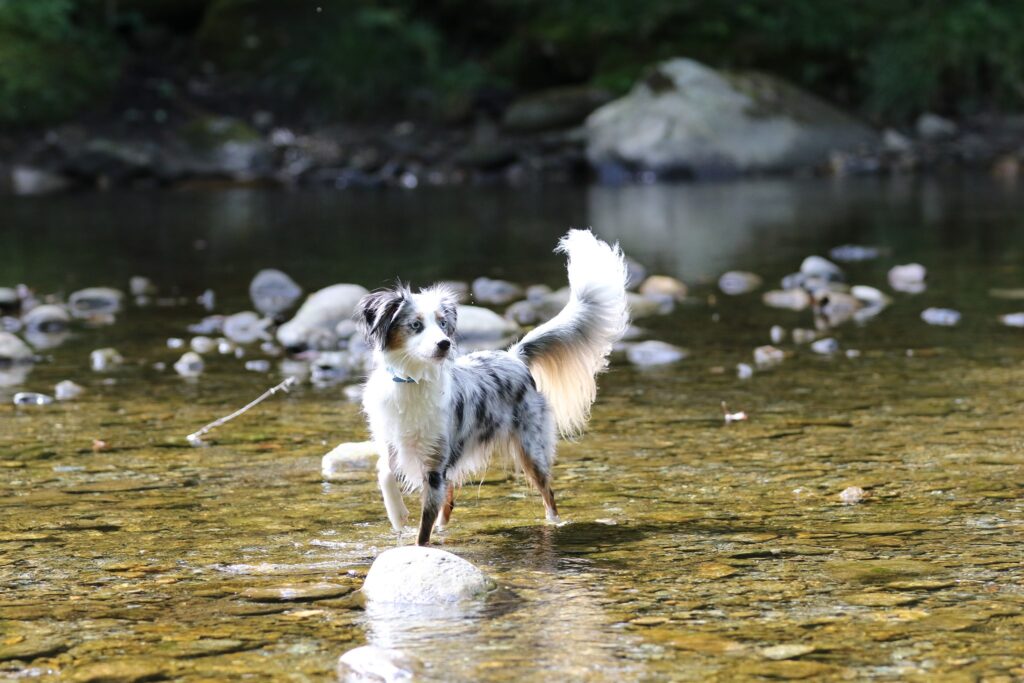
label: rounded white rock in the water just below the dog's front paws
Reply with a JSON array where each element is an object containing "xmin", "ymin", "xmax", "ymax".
[{"xmin": 362, "ymin": 546, "xmax": 494, "ymax": 605}]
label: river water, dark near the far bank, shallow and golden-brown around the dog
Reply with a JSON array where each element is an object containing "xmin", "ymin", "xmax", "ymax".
[{"xmin": 0, "ymin": 180, "xmax": 1024, "ymax": 681}]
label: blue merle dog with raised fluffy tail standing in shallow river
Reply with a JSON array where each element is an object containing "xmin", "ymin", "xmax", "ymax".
[{"xmin": 356, "ymin": 229, "xmax": 629, "ymax": 546}]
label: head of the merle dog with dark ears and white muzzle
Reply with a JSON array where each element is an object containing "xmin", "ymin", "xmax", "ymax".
[{"xmin": 356, "ymin": 285, "xmax": 458, "ymax": 361}]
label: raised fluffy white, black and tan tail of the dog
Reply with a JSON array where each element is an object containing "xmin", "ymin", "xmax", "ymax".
[{"xmin": 509, "ymin": 230, "xmax": 629, "ymax": 438}]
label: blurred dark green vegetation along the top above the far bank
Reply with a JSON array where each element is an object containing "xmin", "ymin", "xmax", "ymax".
[{"xmin": 6, "ymin": 0, "xmax": 1024, "ymax": 123}]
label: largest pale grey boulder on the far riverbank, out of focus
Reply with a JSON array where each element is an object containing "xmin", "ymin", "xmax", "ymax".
[{"xmin": 586, "ymin": 58, "xmax": 878, "ymax": 176}]
